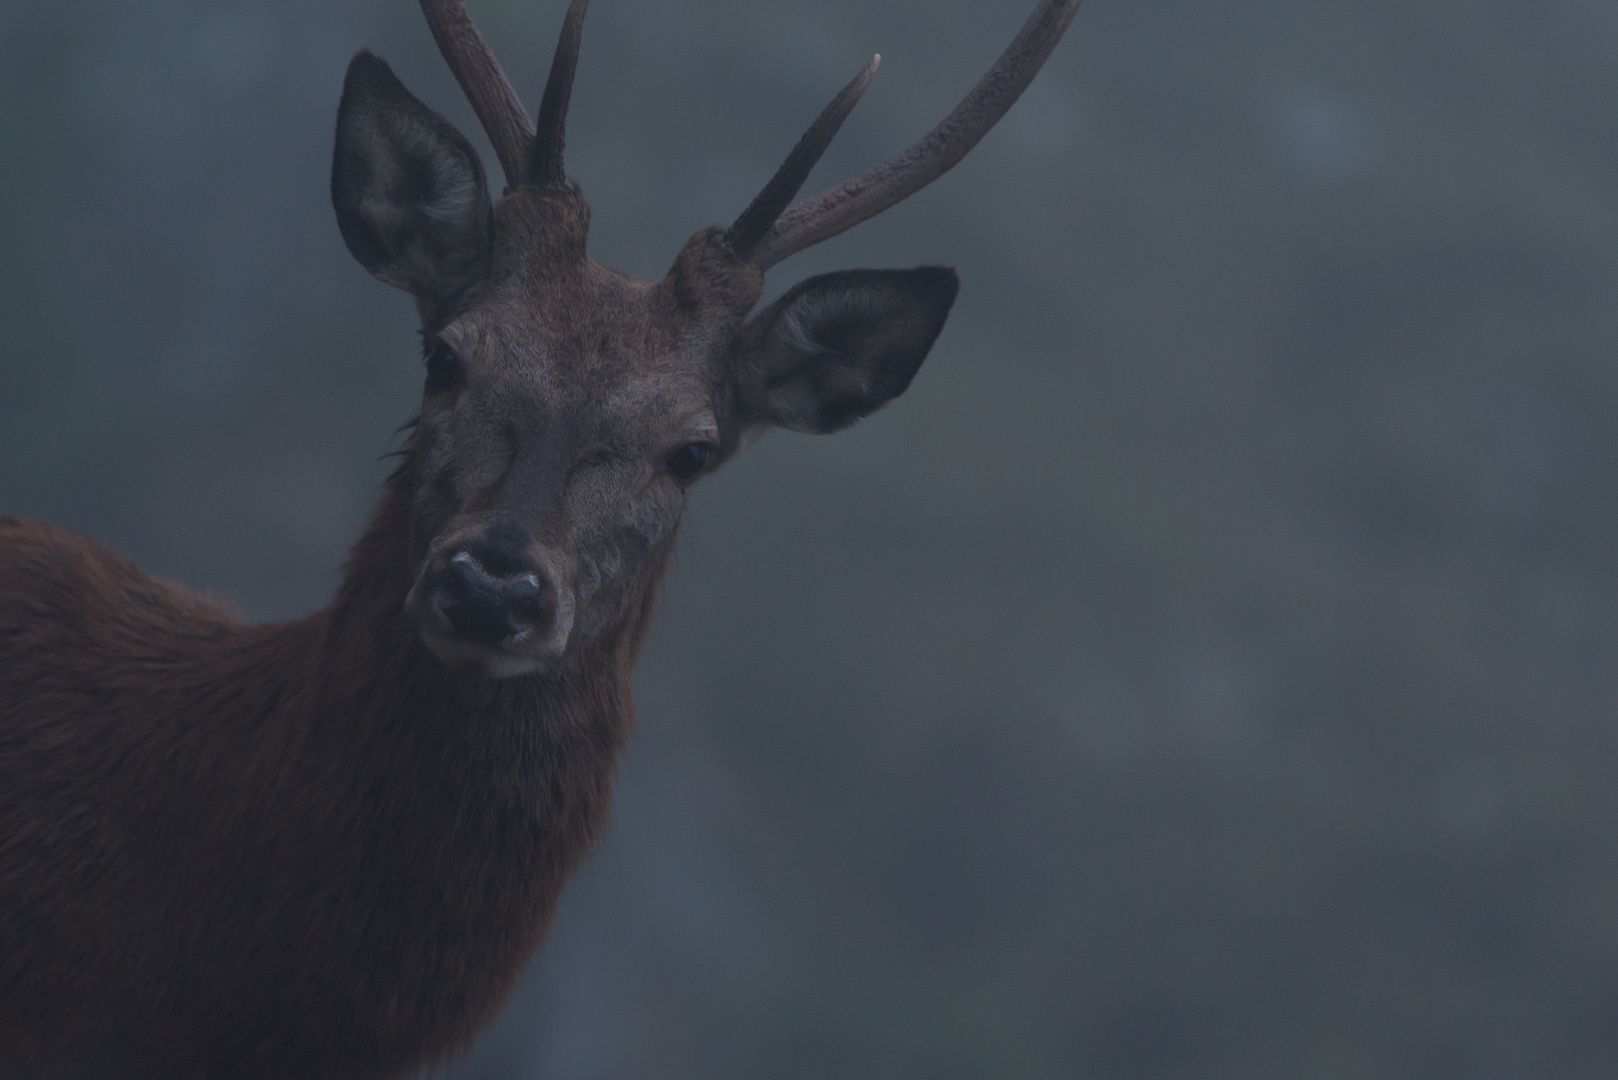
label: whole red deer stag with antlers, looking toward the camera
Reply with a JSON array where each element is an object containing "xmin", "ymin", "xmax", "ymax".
[{"xmin": 0, "ymin": 0, "xmax": 1079, "ymax": 1080}]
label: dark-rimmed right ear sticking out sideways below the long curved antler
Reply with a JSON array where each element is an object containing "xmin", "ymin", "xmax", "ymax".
[{"xmin": 736, "ymin": 266, "xmax": 961, "ymax": 434}]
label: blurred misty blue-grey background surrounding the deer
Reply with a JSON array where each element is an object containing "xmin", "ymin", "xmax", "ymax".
[{"xmin": 0, "ymin": 0, "xmax": 1618, "ymax": 1080}]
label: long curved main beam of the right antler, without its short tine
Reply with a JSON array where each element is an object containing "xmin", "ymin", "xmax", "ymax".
[{"xmin": 752, "ymin": 0, "xmax": 1079, "ymax": 269}]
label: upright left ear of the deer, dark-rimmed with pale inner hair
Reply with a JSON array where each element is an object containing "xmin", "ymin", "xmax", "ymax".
[{"xmin": 332, "ymin": 50, "xmax": 493, "ymax": 303}]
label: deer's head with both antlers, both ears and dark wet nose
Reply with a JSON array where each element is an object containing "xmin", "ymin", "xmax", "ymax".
[{"xmin": 332, "ymin": 0, "xmax": 1078, "ymax": 677}]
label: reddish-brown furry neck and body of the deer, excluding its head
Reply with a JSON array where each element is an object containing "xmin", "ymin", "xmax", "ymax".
[{"xmin": 0, "ymin": 443, "xmax": 650, "ymax": 1078}]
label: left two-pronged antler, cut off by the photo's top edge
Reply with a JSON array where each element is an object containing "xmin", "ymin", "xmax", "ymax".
[{"xmin": 421, "ymin": 0, "xmax": 591, "ymax": 188}]
